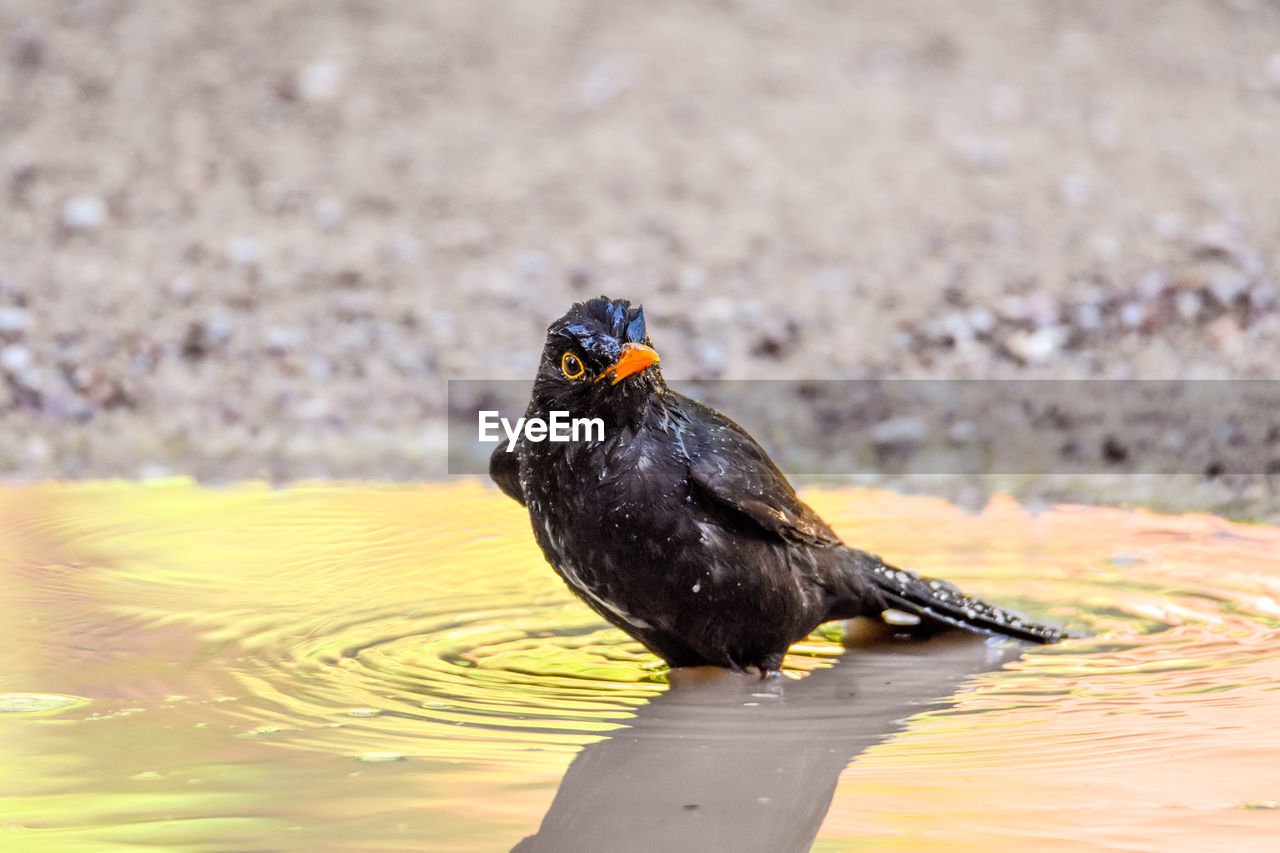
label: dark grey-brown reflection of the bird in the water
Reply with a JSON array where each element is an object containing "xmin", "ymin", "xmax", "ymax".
[{"xmin": 515, "ymin": 634, "xmax": 1019, "ymax": 853}]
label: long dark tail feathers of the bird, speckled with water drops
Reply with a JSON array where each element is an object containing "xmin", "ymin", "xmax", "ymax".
[{"xmin": 865, "ymin": 562, "xmax": 1064, "ymax": 643}]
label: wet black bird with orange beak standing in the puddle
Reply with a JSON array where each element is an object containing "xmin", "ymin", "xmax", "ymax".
[{"xmin": 489, "ymin": 296, "xmax": 1062, "ymax": 674}]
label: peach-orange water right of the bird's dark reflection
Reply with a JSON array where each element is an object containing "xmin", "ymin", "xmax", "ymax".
[{"xmin": 815, "ymin": 502, "xmax": 1280, "ymax": 850}]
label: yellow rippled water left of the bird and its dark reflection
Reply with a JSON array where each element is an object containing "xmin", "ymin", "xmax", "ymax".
[{"xmin": 0, "ymin": 482, "xmax": 634, "ymax": 849}]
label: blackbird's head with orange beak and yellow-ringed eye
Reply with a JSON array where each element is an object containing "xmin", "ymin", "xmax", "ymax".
[{"xmin": 534, "ymin": 296, "xmax": 664, "ymax": 427}]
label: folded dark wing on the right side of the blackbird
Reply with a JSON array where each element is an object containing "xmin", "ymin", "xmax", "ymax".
[{"xmin": 673, "ymin": 394, "xmax": 844, "ymax": 548}]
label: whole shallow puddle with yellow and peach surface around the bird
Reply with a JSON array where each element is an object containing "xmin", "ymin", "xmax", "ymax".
[{"xmin": 0, "ymin": 482, "xmax": 1280, "ymax": 852}]
